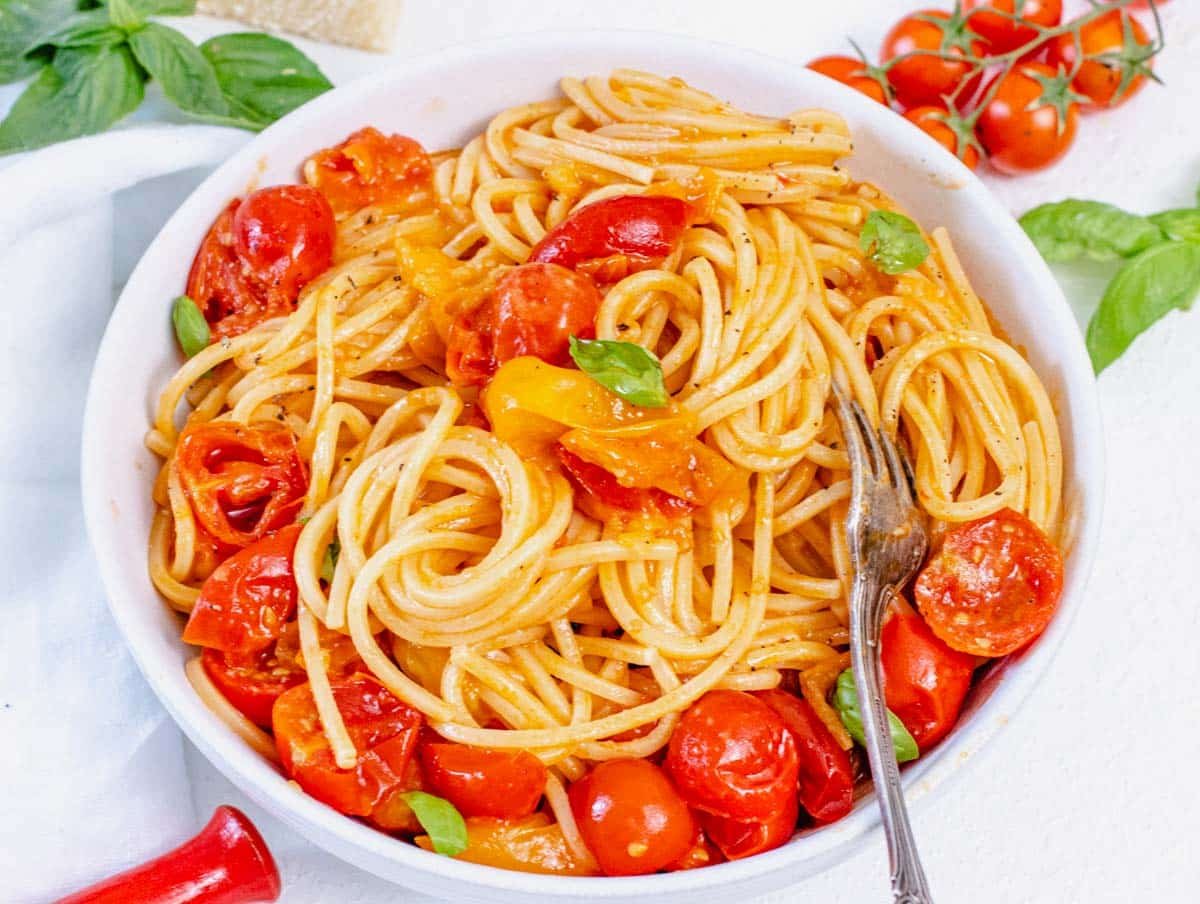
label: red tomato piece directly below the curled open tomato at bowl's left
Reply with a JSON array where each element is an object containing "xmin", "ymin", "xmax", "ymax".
[{"xmin": 184, "ymin": 525, "xmax": 300, "ymax": 653}]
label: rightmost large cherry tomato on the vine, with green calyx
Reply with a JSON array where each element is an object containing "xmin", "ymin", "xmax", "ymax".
[{"xmin": 1048, "ymin": 10, "xmax": 1152, "ymax": 107}]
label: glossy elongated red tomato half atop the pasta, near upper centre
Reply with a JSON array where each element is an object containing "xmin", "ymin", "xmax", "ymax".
[{"xmin": 529, "ymin": 194, "xmax": 689, "ymax": 282}]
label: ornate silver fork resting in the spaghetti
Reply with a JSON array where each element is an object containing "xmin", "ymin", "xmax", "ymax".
[{"xmin": 833, "ymin": 382, "xmax": 932, "ymax": 904}]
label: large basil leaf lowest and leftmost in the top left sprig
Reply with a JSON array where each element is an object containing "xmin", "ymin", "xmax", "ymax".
[{"xmin": 0, "ymin": 47, "xmax": 145, "ymax": 154}]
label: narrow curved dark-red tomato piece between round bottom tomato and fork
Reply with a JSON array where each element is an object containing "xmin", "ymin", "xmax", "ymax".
[{"xmin": 758, "ymin": 690, "xmax": 854, "ymax": 825}]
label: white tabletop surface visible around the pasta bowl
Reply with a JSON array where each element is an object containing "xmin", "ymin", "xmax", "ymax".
[{"xmin": 0, "ymin": 0, "xmax": 1200, "ymax": 904}]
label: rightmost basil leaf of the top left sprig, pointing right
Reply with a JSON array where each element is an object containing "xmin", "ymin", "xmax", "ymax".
[{"xmin": 200, "ymin": 32, "xmax": 332, "ymax": 130}]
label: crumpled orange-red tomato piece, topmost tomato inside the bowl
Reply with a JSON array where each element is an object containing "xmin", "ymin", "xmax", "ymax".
[{"xmin": 304, "ymin": 126, "xmax": 433, "ymax": 214}]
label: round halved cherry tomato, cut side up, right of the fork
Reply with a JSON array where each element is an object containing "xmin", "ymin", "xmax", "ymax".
[{"xmin": 913, "ymin": 509, "xmax": 1062, "ymax": 657}]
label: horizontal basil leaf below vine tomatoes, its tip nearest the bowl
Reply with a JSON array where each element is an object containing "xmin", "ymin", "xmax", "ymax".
[{"xmin": 1020, "ymin": 198, "xmax": 1163, "ymax": 261}]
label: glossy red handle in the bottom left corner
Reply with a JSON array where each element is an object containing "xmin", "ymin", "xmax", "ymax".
[{"xmin": 58, "ymin": 807, "xmax": 280, "ymax": 904}]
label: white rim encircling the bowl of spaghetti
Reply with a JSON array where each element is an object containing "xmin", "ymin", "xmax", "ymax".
[{"xmin": 80, "ymin": 30, "xmax": 1104, "ymax": 900}]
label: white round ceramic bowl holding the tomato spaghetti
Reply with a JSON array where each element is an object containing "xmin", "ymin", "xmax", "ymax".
[{"xmin": 83, "ymin": 31, "xmax": 1103, "ymax": 904}]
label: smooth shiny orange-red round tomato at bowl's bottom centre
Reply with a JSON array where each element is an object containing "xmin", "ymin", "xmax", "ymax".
[{"xmin": 569, "ymin": 760, "xmax": 696, "ymax": 875}]
